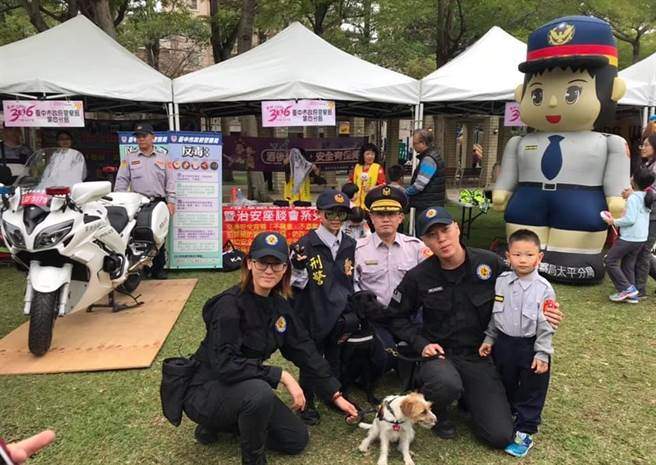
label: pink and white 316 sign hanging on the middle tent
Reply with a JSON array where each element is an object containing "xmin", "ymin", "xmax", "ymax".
[{"xmin": 262, "ymin": 100, "xmax": 335, "ymax": 128}]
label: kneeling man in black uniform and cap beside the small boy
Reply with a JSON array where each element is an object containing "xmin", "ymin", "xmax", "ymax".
[{"xmin": 389, "ymin": 207, "xmax": 562, "ymax": 448}]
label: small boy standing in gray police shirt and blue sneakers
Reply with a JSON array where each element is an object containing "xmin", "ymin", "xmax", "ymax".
[{"xmin": 478, "ymin": 229, "xmax": 556, "ymax": 457}]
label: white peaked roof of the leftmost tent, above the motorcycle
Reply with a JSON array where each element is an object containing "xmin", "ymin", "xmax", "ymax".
[{"xmin": 0, "ymin": 15, "xmax": 171, "ymax": 102}]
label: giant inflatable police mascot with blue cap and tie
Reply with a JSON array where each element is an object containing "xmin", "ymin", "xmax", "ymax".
[{"xmin": 492, "ymin": 16, "xmax": 630, "ymax": 283}]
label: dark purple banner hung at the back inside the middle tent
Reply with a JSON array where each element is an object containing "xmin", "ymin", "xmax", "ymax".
[{"xmin": 223, "ymin": 136, "xmax": 367, "ymax": 171}]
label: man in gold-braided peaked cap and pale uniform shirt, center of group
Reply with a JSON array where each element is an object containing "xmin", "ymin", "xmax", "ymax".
[{"xmin": 354, "ymin": 184, "xmax": 432, "ymax": 305}]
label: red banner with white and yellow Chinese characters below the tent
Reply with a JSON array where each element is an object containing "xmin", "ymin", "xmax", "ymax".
[{"xmin": 223, "ymin": 205, "xmax": 319, "ymax": 252}]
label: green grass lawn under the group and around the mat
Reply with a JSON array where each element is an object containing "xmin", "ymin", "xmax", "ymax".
[{"xmin": 0, "ymin": 208, "xmax": 656, "ymax": 465}]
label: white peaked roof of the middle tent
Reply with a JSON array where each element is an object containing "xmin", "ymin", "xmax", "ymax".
[{"xmin": 173, "ymin": 22, "xmax": 419, "ymax": 105}]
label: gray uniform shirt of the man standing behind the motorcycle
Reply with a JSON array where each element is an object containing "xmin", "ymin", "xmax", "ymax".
[{"xmin": 114, "ymin": 149, "xmax": 175, "ymax": 203}]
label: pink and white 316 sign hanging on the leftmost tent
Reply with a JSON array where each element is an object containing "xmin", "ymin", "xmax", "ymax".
[{"xmin": 2, "ymin": 100, "xmax": 84, "ymax": 128}]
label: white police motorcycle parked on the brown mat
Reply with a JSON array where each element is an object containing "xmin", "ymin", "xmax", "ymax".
[{"xmin": 0, "ymin": 149, "xmax": 169, "ymax": 356}]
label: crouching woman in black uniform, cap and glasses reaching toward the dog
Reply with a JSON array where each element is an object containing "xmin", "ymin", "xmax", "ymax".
[{"xmin": 184, "ymin": 232, "xmax": 357, "ymax": 465}]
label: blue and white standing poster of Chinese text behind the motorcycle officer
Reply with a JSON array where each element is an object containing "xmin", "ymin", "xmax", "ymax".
[{"xmin": 119, "ymin": 132, "xmax": 223, "ymax": 269}]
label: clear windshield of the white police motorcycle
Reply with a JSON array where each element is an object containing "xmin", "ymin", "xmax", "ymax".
[{"xmin": 18, "ymin": 148, "xmax": 87, "ymax": 191}]
